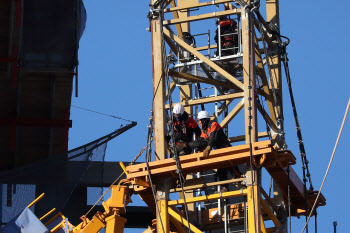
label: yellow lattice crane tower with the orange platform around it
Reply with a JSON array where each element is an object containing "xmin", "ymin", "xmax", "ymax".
[{"xmin": 126, "ymin": 0, "xmax": 325, "ymax": 232}]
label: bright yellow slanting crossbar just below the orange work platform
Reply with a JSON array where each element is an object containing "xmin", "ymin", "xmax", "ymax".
[{"xmin": 168, "ymin": 189, "xmax": 247, "ymax": 206}]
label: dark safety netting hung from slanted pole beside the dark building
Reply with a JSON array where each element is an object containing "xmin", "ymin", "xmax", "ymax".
[{"xmin": 0, "ymin": 122, "xmax": 136, "ymax": 225}]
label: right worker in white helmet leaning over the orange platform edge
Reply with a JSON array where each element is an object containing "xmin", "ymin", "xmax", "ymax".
[{"xmin": 188, "ymin": 111, "xmax": 241, "ymax": 192}]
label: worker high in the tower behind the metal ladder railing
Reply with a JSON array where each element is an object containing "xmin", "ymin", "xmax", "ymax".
[{"xmin": 214, "ymin": 16, "xmax": 238, "ymax": 57}]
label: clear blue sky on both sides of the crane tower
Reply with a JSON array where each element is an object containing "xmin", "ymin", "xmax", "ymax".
[{"xmin": 69, "ymin": 0, "xmax": 350, "ymax": 233}]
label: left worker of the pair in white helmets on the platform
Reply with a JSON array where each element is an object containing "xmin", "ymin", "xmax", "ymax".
[{"xmin": 173, "ymin": 104, "xmax": 201, "ymax": 155}]
